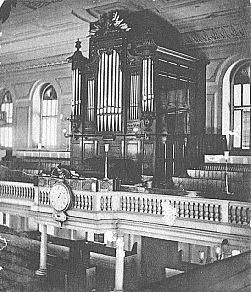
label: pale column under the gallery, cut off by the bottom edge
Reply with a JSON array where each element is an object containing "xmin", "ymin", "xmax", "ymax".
[{"xmin": 114, "ymin": 235, "xmax": 125, "ymax": 292}]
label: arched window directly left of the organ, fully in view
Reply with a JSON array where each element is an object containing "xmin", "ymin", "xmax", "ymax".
[{"xmin": 40, "ymin": 83, "xmax": 58, "ymax": 147}]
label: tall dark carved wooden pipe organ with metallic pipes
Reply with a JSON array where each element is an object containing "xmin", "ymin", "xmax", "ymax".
[{"xmin": 68, "ymin": 10, "xmax": 206, "ymax": 184}]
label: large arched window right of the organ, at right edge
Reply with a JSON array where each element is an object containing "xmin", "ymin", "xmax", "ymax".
[{"xmin": 230, "ymin": 63, "xmax": 251, "ymax": 149}]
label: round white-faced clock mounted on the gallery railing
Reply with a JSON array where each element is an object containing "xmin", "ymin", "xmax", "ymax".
[{"xmin": 50, "ymin": 182, "xmax": 72, "ymax": 212}]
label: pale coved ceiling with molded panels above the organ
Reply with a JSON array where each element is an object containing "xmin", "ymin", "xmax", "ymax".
[{"xmin": 0, "ymin": 0, "xmax": 251, "ymax": 63}]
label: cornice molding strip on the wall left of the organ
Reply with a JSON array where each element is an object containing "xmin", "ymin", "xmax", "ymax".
[{"xmin": 0, "ymin": 54, "xmax": 70, "ymax": 74}]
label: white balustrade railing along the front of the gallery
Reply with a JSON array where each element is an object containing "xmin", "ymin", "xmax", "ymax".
[{"xmin": 0, "ymin": 181, "xmax": 251, "ymax": 226}]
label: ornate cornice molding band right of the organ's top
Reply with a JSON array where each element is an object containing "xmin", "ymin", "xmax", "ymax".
[{"xmin": 182, "ymin": 23, "xmax": 251, "ymax": 46}]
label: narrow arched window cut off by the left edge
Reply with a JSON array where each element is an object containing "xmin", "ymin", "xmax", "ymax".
[{"xmin": 0, "ymin": 90, "xmax": 13, "ymax": 147}]
